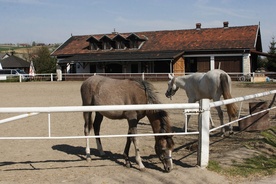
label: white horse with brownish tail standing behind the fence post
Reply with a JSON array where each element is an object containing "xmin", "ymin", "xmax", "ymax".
[{"xmin": 165, "ymin": 69, "xmax": 237, "ymax": 133}]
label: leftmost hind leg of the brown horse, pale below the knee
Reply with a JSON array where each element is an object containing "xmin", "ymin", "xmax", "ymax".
[{"xmin": 83, "ymin": 112, "xmax": 92, "ymax": 161}]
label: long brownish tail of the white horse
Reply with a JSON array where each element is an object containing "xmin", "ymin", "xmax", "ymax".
[{"xmin": 220, "ymin": 73, "xmax": 238, "ymax": 118}]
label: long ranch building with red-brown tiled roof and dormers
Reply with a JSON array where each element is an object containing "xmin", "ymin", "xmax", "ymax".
[{"xmin": 51, "ymin": 22, "xmax": 264, "ymax": 78}]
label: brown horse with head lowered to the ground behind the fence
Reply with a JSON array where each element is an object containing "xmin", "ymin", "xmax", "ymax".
[{"xmin": 81, "ymin": 75, "xmax": 174, "ymax": 172}]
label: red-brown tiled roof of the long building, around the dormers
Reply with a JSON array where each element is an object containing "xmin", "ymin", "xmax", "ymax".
[{"xmin": 52, "ymin": 25, "xmax": 259, "ymax": 56}]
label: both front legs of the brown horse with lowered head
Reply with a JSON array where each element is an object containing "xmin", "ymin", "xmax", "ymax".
[{"xmin": 124, "ymin": 119, "xmax": 145, "ymax": 170}]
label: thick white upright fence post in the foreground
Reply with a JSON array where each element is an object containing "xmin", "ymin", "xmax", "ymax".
[{"xmin": 197, "ymin": 99, "xmax": 210, "ymax": 168}]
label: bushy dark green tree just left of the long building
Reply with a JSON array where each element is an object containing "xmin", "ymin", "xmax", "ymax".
[{"xmin": 33, "ymin": 47, "xmax": 56, "ymax": 73}]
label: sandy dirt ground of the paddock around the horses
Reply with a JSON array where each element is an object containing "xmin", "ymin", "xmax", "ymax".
[{"xmin": 0, "ymin": 82, "xmax": 276, "ymax": 184}]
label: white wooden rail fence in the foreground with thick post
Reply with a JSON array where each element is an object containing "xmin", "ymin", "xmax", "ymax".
[{"xmin": 0, "ymin": 90, "xmax": 276, "ymax": 167}]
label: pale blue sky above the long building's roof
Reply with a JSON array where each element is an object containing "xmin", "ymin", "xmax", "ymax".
[{"xmin": 0, "ymin": 0, "xmax": 276, "ymax": 52}]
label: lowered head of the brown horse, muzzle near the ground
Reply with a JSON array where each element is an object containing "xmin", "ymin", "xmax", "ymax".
[{"xmin": 154, "ymin": 136, "xmax": 174, "ymax": 172}]
